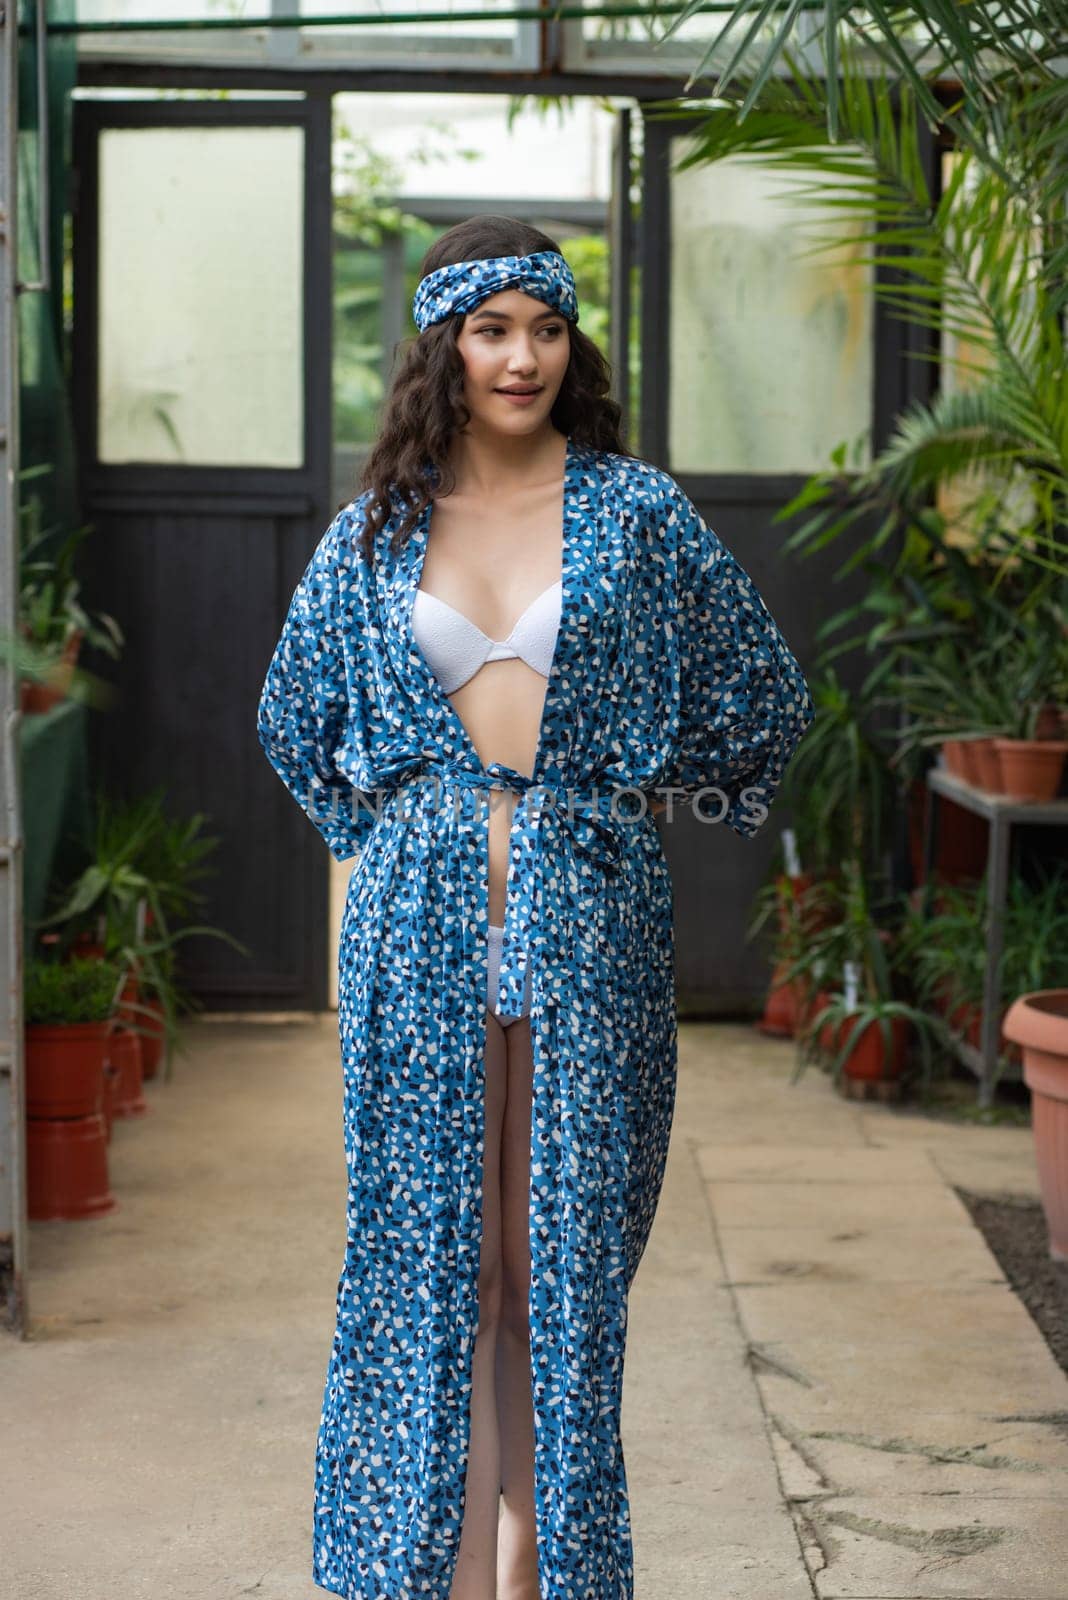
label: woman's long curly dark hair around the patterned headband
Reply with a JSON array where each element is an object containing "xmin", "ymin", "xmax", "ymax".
[{"xmin": 360, "ymin": 214, "xmax": 630, "ymax": 560}]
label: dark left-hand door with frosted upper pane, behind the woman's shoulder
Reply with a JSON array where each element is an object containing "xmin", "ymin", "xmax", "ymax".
[{"xmin": 74, "ymin": 94, "xmax": 336, "ymax": 1010}]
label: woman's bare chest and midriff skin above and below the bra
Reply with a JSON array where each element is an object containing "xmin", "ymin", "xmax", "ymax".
[{"xmin": 419, "ymin": 467, "xmax": 563, "ymax": 926}]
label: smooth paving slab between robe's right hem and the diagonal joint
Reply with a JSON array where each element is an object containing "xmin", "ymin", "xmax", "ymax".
[{"xmin": 622, "ymin": 1132, "xmax": 812, "ymax": 1600}]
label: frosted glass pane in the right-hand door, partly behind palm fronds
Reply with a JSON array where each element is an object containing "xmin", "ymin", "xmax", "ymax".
[{"xmin": 668, "ymin": 139, "xmax": 873, "ymax": 474}]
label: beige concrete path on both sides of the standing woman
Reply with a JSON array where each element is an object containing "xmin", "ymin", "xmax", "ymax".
[{"xmin": 0, "ymin": 1014, "xmax": 1068, "ymax": 1600}]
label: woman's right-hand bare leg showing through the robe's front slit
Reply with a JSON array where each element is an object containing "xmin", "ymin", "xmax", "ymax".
[{"xmin": 496, "ymin": 1016, "xmax": 539, "ymax": 1600}]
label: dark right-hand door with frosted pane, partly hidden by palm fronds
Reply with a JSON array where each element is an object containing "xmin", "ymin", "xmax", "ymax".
[{"xmin": 640, "ymin": 115, "xmax": 937, "ymax": 1014}]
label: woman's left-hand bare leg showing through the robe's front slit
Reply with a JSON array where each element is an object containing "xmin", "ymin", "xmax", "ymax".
[{"xmin": 449, "ymin": 1011, "xmax": 507, "ymax": 1600}]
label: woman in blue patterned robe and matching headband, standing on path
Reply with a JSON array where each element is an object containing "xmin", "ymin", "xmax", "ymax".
[{"xmin": 259, "ymin": 216, "xmax": 812, "ymax": 1600}]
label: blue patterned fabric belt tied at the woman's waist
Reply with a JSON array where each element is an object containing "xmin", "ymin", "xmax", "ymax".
[{"xmin": 406, "ymin": 762, "xmax": 625, "ymax": 1016}]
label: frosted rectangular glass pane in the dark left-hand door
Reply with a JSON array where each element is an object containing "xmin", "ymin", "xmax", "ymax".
[{"xmin": 98, "ymin": 126, "xmax": 304, "ymax": 467}]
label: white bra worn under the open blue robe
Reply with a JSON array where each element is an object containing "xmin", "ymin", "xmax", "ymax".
[{"xmin": 411, "ymin": 578, "xmax": 563, "ymax": 694}]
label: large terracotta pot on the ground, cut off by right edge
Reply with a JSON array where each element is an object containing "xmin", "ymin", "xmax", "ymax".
[{"xmin": 1002, "ymin": 989, "xmax": 1068, "ymax": 1261}]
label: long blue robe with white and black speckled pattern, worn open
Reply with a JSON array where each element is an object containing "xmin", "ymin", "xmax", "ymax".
[{"xmin": 259, "ymin": 442, "xmax": 812, "ymax": 1600}]
